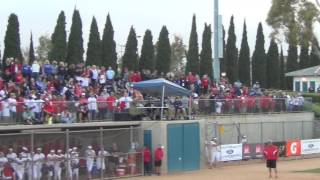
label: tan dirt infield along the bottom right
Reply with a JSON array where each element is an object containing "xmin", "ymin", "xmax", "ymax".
[{"xmin": 132, "ymin": 158, "xmax": 320, "ymax": 180}]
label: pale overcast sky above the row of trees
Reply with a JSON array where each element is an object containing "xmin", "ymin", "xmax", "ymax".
[{"xmin": 0, "ymin": 0, "xmax": 271, "ymax": 56}]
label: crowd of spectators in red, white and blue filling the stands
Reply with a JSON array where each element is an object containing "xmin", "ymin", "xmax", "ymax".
[{"xmin": 0, "ymin": 58, "xmax": 303, "ymax": 124}]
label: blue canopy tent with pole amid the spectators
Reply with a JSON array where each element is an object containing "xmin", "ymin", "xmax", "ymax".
[{"xmin": 133, "ymin": 78, "xmax": 192, "ymax": 119}]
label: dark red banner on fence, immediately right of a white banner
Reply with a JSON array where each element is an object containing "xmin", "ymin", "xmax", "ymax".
[{"xmin": 242, "ymin": 144, "xmax": 263, "ymax": 159}]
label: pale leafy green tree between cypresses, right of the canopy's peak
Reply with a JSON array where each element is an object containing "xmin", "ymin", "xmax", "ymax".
[{"xmin": 170, "ymin": 35, "xmax": 186, "ymax": 74}]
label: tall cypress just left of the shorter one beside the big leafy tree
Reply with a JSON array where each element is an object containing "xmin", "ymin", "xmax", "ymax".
[{"xmin": 252, "ymin": 23, "xmax": 267, "ymax": 87}]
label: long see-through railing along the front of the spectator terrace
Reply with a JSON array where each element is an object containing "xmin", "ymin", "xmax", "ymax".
[{"xmin": 0, "ymin": 97, "xmax": 311, "ymax": 124}]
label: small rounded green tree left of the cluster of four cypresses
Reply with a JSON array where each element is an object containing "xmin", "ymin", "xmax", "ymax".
[{"xmin": 36, "ymin": 35, "xmax": 52, "ymax": 61}]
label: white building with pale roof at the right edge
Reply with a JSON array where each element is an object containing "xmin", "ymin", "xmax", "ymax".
[{"xmin": 286, "ymin": 66, "xmax": 320, "ymax": 92}]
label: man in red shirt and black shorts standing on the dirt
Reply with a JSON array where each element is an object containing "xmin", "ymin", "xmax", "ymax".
[{"xmin": 263, "ymin": 140, "xmax": 279, "ymax": 178}]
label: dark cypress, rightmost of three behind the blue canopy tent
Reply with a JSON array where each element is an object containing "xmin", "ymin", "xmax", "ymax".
[{"xmin": 156, "ymin": 26, "xmax": 171, "ymax": 74}]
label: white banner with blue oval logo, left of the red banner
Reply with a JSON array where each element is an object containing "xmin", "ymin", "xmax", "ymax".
[{"xmin": 221, "ymin": 144, "xmax": 242, "ymax": 161}]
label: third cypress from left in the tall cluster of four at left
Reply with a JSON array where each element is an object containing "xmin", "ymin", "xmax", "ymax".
[{"xmin": 86, "ymin": 17, "xmax": 103, "ymax": 66}]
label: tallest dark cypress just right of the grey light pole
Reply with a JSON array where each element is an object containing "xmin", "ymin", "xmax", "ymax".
[{"xmin": 225, "ymin": 16, "xmax": 238, "ymax": 83}]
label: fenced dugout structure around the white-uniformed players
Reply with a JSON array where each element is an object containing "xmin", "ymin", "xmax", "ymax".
[{"xmin": 0, "ymin": 122, "xmax": 143, "ymax": 178}]
